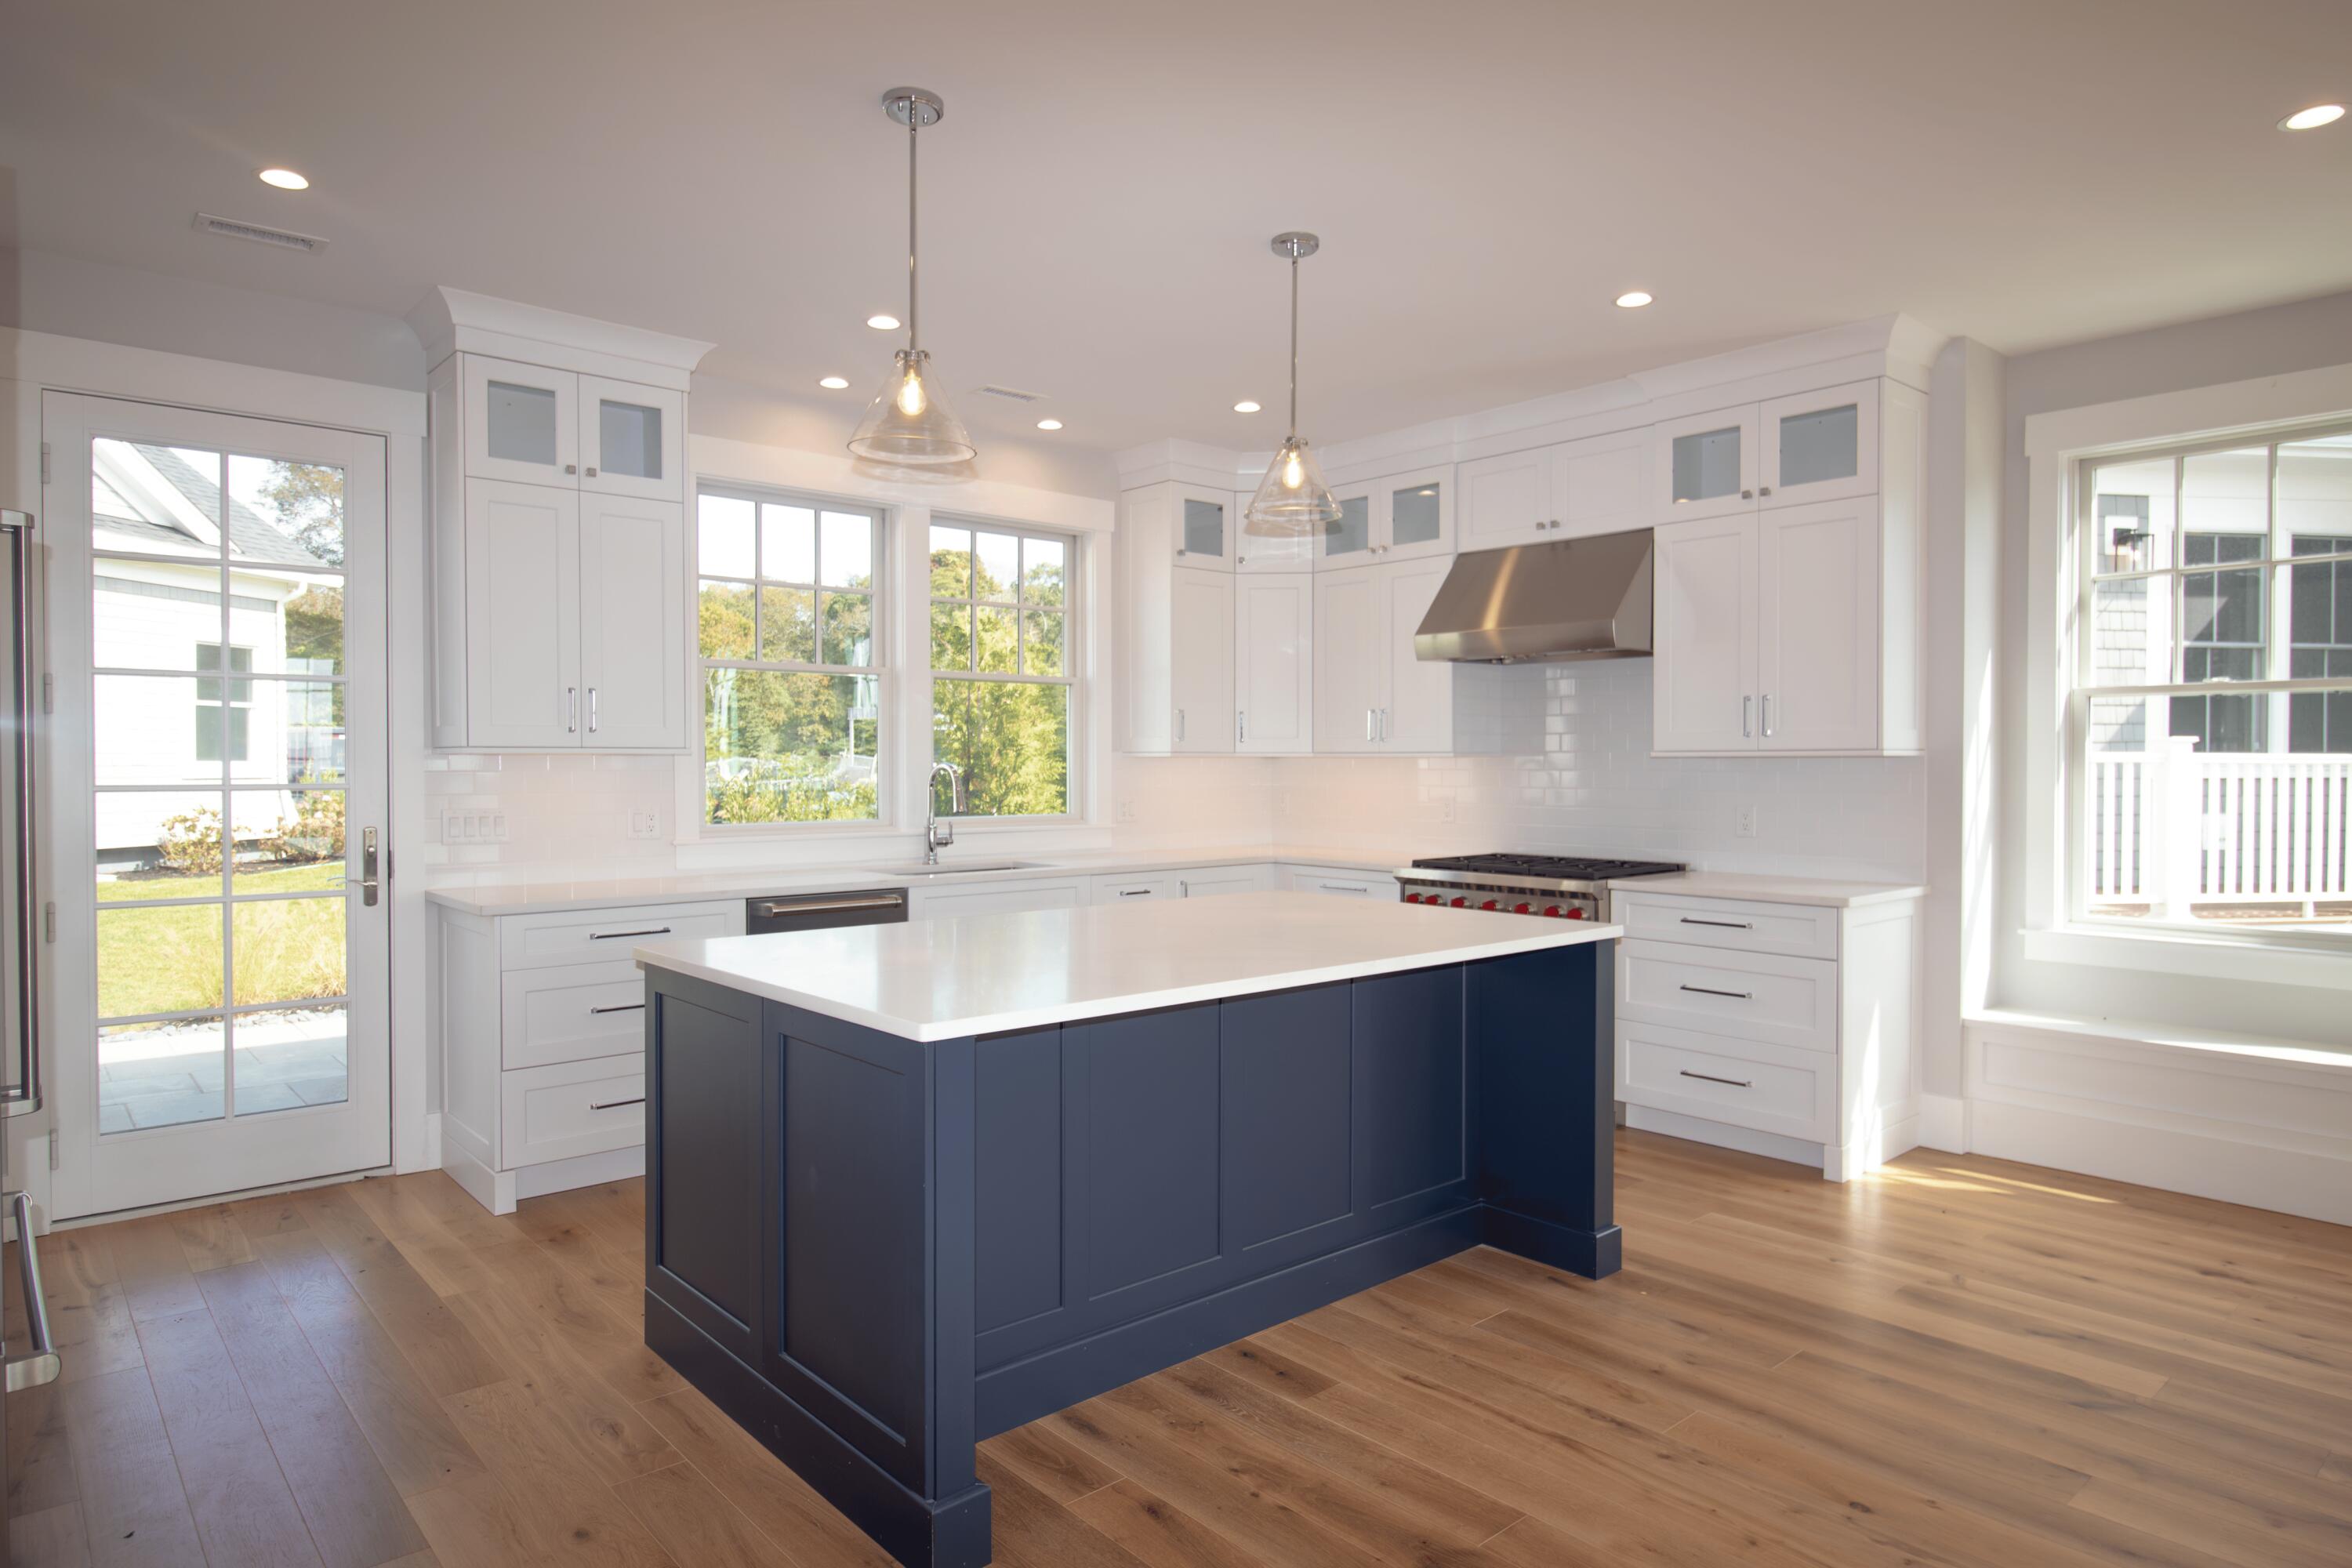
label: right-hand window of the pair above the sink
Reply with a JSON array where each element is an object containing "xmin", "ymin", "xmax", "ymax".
[{"xmin": 929, "ymin": 517, "xmax": 1082, "ymax": 820}]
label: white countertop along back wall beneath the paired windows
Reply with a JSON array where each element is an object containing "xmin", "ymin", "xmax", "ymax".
[{"xmin": 426, "ymin": 844, "xmax": 1428, "ymax": 916}]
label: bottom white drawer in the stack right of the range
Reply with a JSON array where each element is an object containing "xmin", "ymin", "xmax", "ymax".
[{"xmin": 1616, "ymin": 1018, "xmax": 1837, "ymax": 1142}]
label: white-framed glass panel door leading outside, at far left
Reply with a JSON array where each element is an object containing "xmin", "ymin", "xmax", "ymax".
[{"xmin": 45, "ymin": 397, "xmax": 390, "ymax": 1215}]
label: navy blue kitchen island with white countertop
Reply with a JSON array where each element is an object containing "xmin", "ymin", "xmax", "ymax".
[{"xmin": 637, "ymin": 893, "xmax": 1621, "ymax": 1568}]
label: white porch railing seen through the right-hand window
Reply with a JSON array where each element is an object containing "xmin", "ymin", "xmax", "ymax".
[{"xmin": 2084, "ymin": 736, "xmax": 2352, "ymax": 914}]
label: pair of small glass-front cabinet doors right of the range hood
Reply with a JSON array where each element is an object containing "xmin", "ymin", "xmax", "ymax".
[{"xmin": 1653, "ymin": 381, "xmax": 1884, "ymax": 524}]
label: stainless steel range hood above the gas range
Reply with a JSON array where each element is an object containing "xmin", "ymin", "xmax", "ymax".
[{"xmin": 1414, "ymin": 529, "xmax": 1651, "ymax": 663}]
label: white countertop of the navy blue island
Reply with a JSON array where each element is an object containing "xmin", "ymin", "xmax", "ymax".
[{"xmin": 635, "ymin": 893, "xmax": 1625, "ymax": 1039}]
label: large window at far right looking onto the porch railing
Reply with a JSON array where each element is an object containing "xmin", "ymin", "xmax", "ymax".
[{"xmin": 2067, "ymin": 426, "xmax": 2352, "ymax": 942}]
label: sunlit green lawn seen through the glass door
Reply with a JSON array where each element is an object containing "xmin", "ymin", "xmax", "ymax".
[{"xmin": 96, "ymin": 860, "xmax": 343, "ymax": 1018}]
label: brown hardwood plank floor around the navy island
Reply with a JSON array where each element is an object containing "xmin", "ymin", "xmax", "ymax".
[{"xmin": 7, "ymin": 1133, "xmax": 2352, "ymax": 1568}]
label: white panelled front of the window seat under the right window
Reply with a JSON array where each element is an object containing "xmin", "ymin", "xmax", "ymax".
[{"xmin": 1966, "ymin": 1020, "xmax": 2352, "ymax": 1225}]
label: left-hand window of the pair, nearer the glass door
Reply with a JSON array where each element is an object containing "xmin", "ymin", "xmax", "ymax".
[{"xmin": 696, "ymin": 485, "xmax": 889, "ymax": 827}]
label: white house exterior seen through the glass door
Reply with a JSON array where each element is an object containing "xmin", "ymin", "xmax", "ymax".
[{"xmin": 92, "ymin": 440, "xmax": 343, "ymax": 874}]
